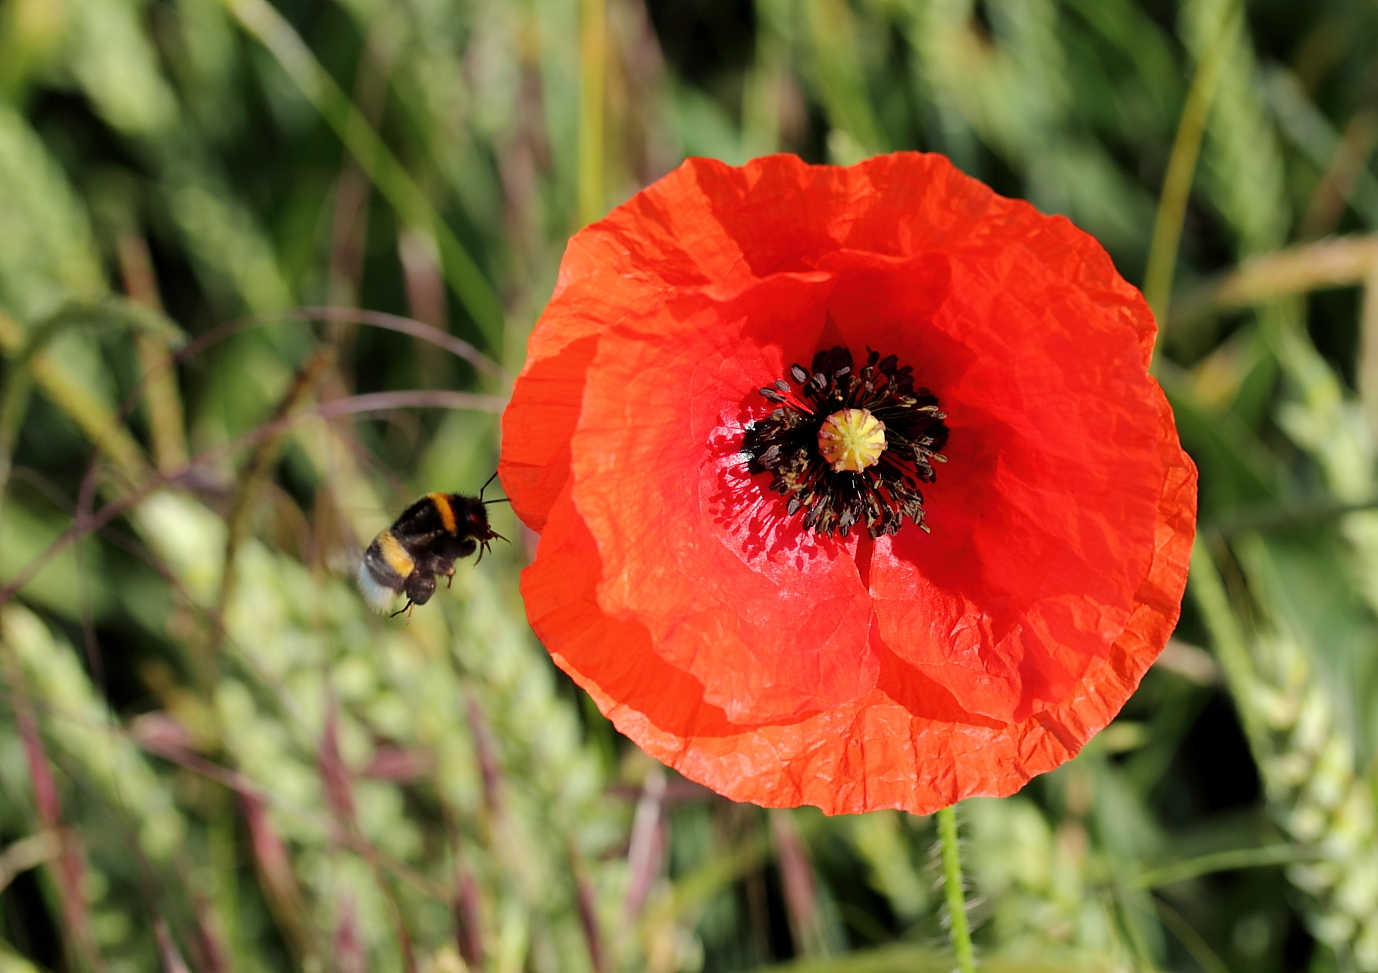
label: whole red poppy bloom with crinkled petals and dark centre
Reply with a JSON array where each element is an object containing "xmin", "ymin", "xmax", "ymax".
[{"xmin": 500, "ymin": 153, "xmax": 1196, "ymax": 813}]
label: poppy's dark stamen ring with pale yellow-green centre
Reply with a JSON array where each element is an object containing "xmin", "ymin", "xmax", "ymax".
[{"xmin": 741, "ymin": 346, "xmax": 948, "ymax": 537}]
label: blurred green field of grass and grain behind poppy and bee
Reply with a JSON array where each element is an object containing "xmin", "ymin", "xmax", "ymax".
[{"xmin": 0, "ymin": 0, "xmax": 1378, "ymax": 973}]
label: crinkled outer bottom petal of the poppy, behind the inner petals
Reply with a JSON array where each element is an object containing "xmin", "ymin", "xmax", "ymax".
[{"xmin": 522, "ymin": 385, "xmax": 1196, "ymax": 815}]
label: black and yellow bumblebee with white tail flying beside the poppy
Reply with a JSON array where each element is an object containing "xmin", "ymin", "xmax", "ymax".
[{"xmin": 358, "ymin": 474, "xmax": 506, "ymax": 616}]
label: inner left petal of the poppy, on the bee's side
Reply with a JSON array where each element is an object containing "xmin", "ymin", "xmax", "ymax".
[{"xmin": 572, "ymin": 274, "xmax": 876, "ymax": 722}]
